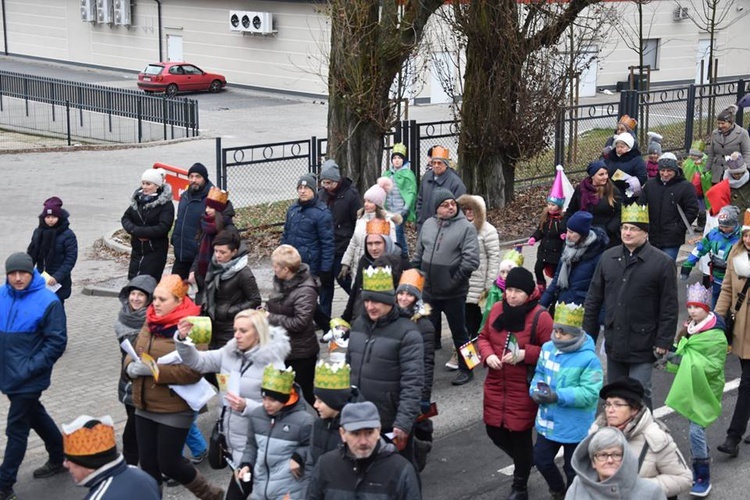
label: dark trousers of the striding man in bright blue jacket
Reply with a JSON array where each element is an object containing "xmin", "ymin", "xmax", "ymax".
[{"xmin": 0, "ymin": 392, "xmax": 65, "ymax": 490}]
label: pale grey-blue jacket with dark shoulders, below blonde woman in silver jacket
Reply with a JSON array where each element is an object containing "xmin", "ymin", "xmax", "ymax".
[{"xmin": 241, "ymin": 384, "xmax": 313, "ymax": 500}]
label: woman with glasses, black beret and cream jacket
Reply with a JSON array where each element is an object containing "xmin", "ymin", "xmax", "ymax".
[{"xmin": 589, "ymin": 378, "xmax": 693, "ymax": 497}]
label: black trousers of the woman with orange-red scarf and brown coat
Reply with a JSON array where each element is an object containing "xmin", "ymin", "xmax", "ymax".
[{"xmin": 135, "ymin": 415, "xmax": 197, "ymax": 485}]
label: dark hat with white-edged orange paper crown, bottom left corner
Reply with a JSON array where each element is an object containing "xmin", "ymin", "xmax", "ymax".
[{"xmin": 62, "ymin": 415, "xmax": 120, "ymax": 470}]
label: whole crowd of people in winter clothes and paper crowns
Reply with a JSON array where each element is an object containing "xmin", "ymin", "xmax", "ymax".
[{"xmin": 0, "ymin": 102, "xmax": 750, "ymax": 500}]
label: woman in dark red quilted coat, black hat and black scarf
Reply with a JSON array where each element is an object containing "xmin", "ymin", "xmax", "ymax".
[{"xmin": 479, "ymin": 267, "xmax": 552, "ymax": 500}]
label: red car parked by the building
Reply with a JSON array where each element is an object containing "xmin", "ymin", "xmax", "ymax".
[{"xmin": 138, "ymin": 62, "xmax": 227, "ymax": 96}]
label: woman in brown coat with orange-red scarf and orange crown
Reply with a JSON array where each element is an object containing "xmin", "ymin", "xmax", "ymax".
[{"xmin": 124, "ymin": 274, "xmax": 224, "ymax": 500}]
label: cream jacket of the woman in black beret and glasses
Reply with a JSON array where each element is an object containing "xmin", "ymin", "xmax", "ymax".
[{"xmin": 589, "ymin": 406, "xmax": 693, "ymax": 497}]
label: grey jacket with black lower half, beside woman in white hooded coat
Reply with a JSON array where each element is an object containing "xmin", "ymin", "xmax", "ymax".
[{"xmin": 412, "ymin": 210, "xmax": 479, "ymax": 301}]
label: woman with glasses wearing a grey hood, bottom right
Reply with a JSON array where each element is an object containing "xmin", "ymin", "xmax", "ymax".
[{"xmin": 565, "ymin": 427, "xmax": 666, "ymax": 500}]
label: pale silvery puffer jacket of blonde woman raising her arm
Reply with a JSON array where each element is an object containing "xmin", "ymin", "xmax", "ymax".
[{"xmin": 175, "ymin": 326, "xmax": 290, "ymax": 464}]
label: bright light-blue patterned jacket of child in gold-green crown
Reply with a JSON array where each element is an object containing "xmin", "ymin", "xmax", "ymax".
[{"xmin": 529, "ymin": 333, "xmax": 603, "ymax": 443}]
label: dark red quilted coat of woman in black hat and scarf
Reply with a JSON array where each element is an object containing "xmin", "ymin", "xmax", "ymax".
[{"xmin": 479, "ymin": 296, "xmax": 552, "ymax": 432}]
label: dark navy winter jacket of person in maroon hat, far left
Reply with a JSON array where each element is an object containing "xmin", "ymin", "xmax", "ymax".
[{"xmin": 26, "ymin": 210, "xmax": 78, "ymax": 300}]
